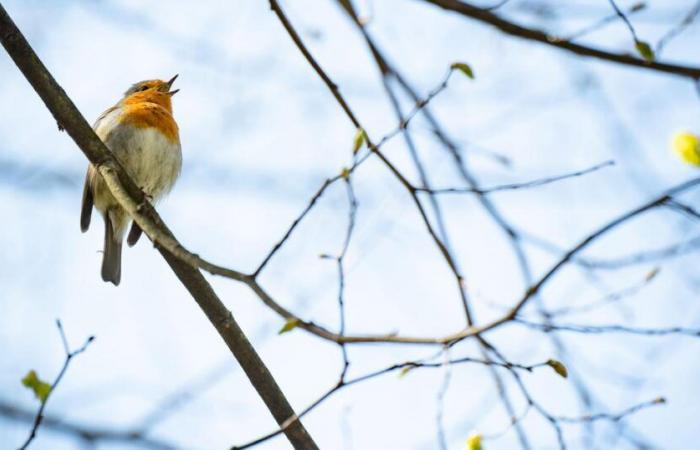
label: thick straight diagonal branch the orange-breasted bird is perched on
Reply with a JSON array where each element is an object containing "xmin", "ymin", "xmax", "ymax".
[{"xmin": 0, "ymin": 5, "xmax": 317, "ymax": 450}]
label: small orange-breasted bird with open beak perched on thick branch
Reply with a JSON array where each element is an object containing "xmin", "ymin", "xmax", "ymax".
[{"xmin": 80, "ymin": 75, "xmax": 182, "ymax": 286}]
